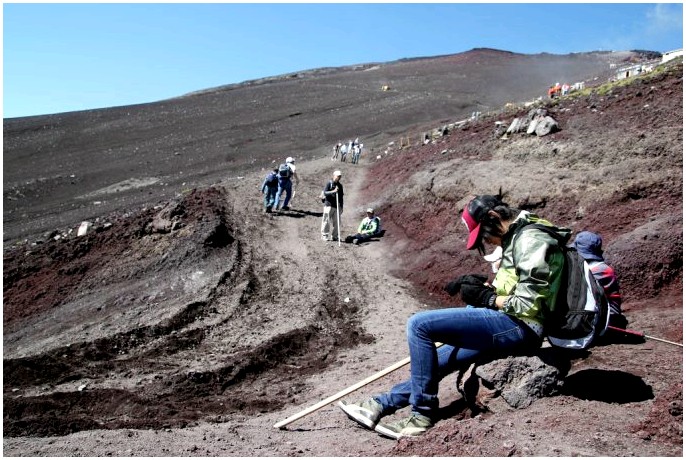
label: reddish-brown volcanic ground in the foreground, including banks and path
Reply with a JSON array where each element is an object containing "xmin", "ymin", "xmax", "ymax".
[{"xmin": 3, "ymin": 53, "xmax": 683, "ymax": 457}]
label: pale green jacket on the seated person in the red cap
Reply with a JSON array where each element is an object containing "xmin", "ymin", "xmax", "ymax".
[{"xmin": 493, "ymin": 211, "xmax": 571, "ymax": 325}]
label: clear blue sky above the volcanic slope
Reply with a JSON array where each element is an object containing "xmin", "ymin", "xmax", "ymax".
[{"xmin": 3, "ymin": 3, "xmax": 683, "ymax": 118}]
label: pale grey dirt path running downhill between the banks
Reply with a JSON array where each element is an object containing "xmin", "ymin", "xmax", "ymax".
[{"xmin": 4, "ymin": 158, "xmax": 440, "ymax": 456}]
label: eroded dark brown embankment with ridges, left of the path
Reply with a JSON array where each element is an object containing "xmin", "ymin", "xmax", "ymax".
[{"xmin": 3, "ymin": 188, "xmax": 372, "ymax": 436}]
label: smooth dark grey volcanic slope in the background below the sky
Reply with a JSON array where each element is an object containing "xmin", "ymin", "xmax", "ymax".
[{"xmin": 3, "ymin": 49, "xmax": 642, "ymax": 244}]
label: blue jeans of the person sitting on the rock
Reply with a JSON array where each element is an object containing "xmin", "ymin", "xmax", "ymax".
[{"xmin": 374, "ymin": 306, "xmax": 541, "ymax": 420}]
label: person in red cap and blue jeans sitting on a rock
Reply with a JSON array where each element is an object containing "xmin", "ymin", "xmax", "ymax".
[{"xmin": 339, "ymin": 195, "xmax": 571, "ymax": 439}]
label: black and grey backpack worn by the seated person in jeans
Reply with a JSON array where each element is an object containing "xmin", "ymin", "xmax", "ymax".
[{"xmin": 512, "ymin": 224, "xmax": 610, "ymax": 350}]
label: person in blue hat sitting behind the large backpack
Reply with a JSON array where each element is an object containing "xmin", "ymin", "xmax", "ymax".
[{"xmin": 573, "ymin": 231, "xmax": 629, "ymax": 332}]
